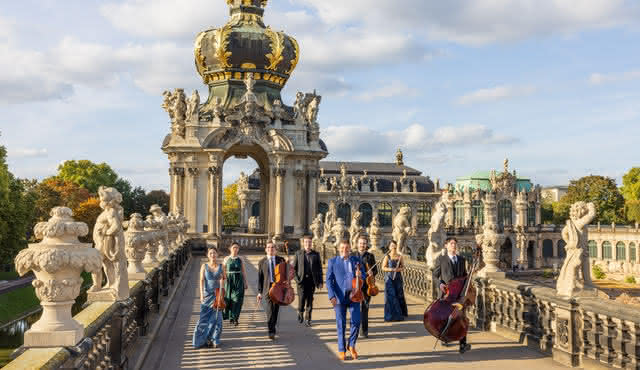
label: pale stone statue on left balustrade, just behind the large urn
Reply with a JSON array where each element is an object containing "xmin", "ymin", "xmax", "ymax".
[{"xmin": 87, "ymin": 186, "xmax": 129, "ymax": 302}]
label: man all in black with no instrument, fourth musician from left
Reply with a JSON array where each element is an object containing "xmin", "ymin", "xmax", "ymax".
[{"xmin": 293, "ymin": 235, "xmax": 322, "ymax": 326}]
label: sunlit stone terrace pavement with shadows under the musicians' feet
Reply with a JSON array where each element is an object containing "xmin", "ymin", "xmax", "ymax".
[{"xmin": 143, "ymin": 255, "xmax": 562, "ymax": 370}]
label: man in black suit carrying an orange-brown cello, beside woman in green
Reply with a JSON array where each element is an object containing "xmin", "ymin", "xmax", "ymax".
[{"xmin": 257, "ymin": 242, "xmax": 284, "ymax": 340}]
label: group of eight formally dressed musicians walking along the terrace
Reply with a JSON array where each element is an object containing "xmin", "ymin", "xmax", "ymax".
[{"xmin": 193, "ymin": 235, "xmax": 471, "ymax": 360}]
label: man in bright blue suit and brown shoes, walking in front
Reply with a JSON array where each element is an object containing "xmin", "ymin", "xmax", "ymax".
[{"xmin": 326, "ymin": 239, "xmax": 365, "ymax": 360}]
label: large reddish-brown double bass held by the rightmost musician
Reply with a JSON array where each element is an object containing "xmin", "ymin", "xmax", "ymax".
[{"xmin": 423, "ymin": 248, "xmax": 481, "ymax": 345}]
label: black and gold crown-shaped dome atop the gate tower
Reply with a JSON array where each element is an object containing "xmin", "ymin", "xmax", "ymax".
[{"xmin": 195, "ymin": 0, "xmax": 300, "ymax": 92}]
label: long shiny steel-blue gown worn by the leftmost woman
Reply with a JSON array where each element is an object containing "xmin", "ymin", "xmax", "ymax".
[{"xmin": 193, "ymin": 264, "xmax": 223, "ymax": 348}]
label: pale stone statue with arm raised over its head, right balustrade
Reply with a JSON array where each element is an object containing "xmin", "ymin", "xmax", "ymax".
[{"xmin": 556, "ymin": 202, "xmax": 596, "ymax": 297}]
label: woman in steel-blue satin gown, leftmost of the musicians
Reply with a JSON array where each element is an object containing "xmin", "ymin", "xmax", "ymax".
[{"xmin": 193, "ymin": 248, "xmax": 226, "ymax": 348}]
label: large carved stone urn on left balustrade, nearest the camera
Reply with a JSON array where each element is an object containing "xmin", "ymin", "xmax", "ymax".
[{"xmin": 15, "ymin": 207, "xmax": 102, "ymax": 347}]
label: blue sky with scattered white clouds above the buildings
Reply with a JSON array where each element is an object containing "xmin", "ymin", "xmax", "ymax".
[{"xmin": 0, "ymin": 0, "xmax": 640, "ymax": 190}]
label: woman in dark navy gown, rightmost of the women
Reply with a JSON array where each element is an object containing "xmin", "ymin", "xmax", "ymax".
[{"xmin": 382, "ymin": 240, "xmax": 408, "ymax": 321}]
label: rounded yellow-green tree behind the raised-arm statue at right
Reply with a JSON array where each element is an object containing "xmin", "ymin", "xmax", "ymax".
[{"xmin": 553, "ymin": 175, "xmax": 625, "ymax": 224}]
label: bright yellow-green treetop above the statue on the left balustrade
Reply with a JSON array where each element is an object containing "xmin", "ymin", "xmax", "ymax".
[{"xmin": 57, "ymin": 159, "xmax": 119, "ymax": 194}]
